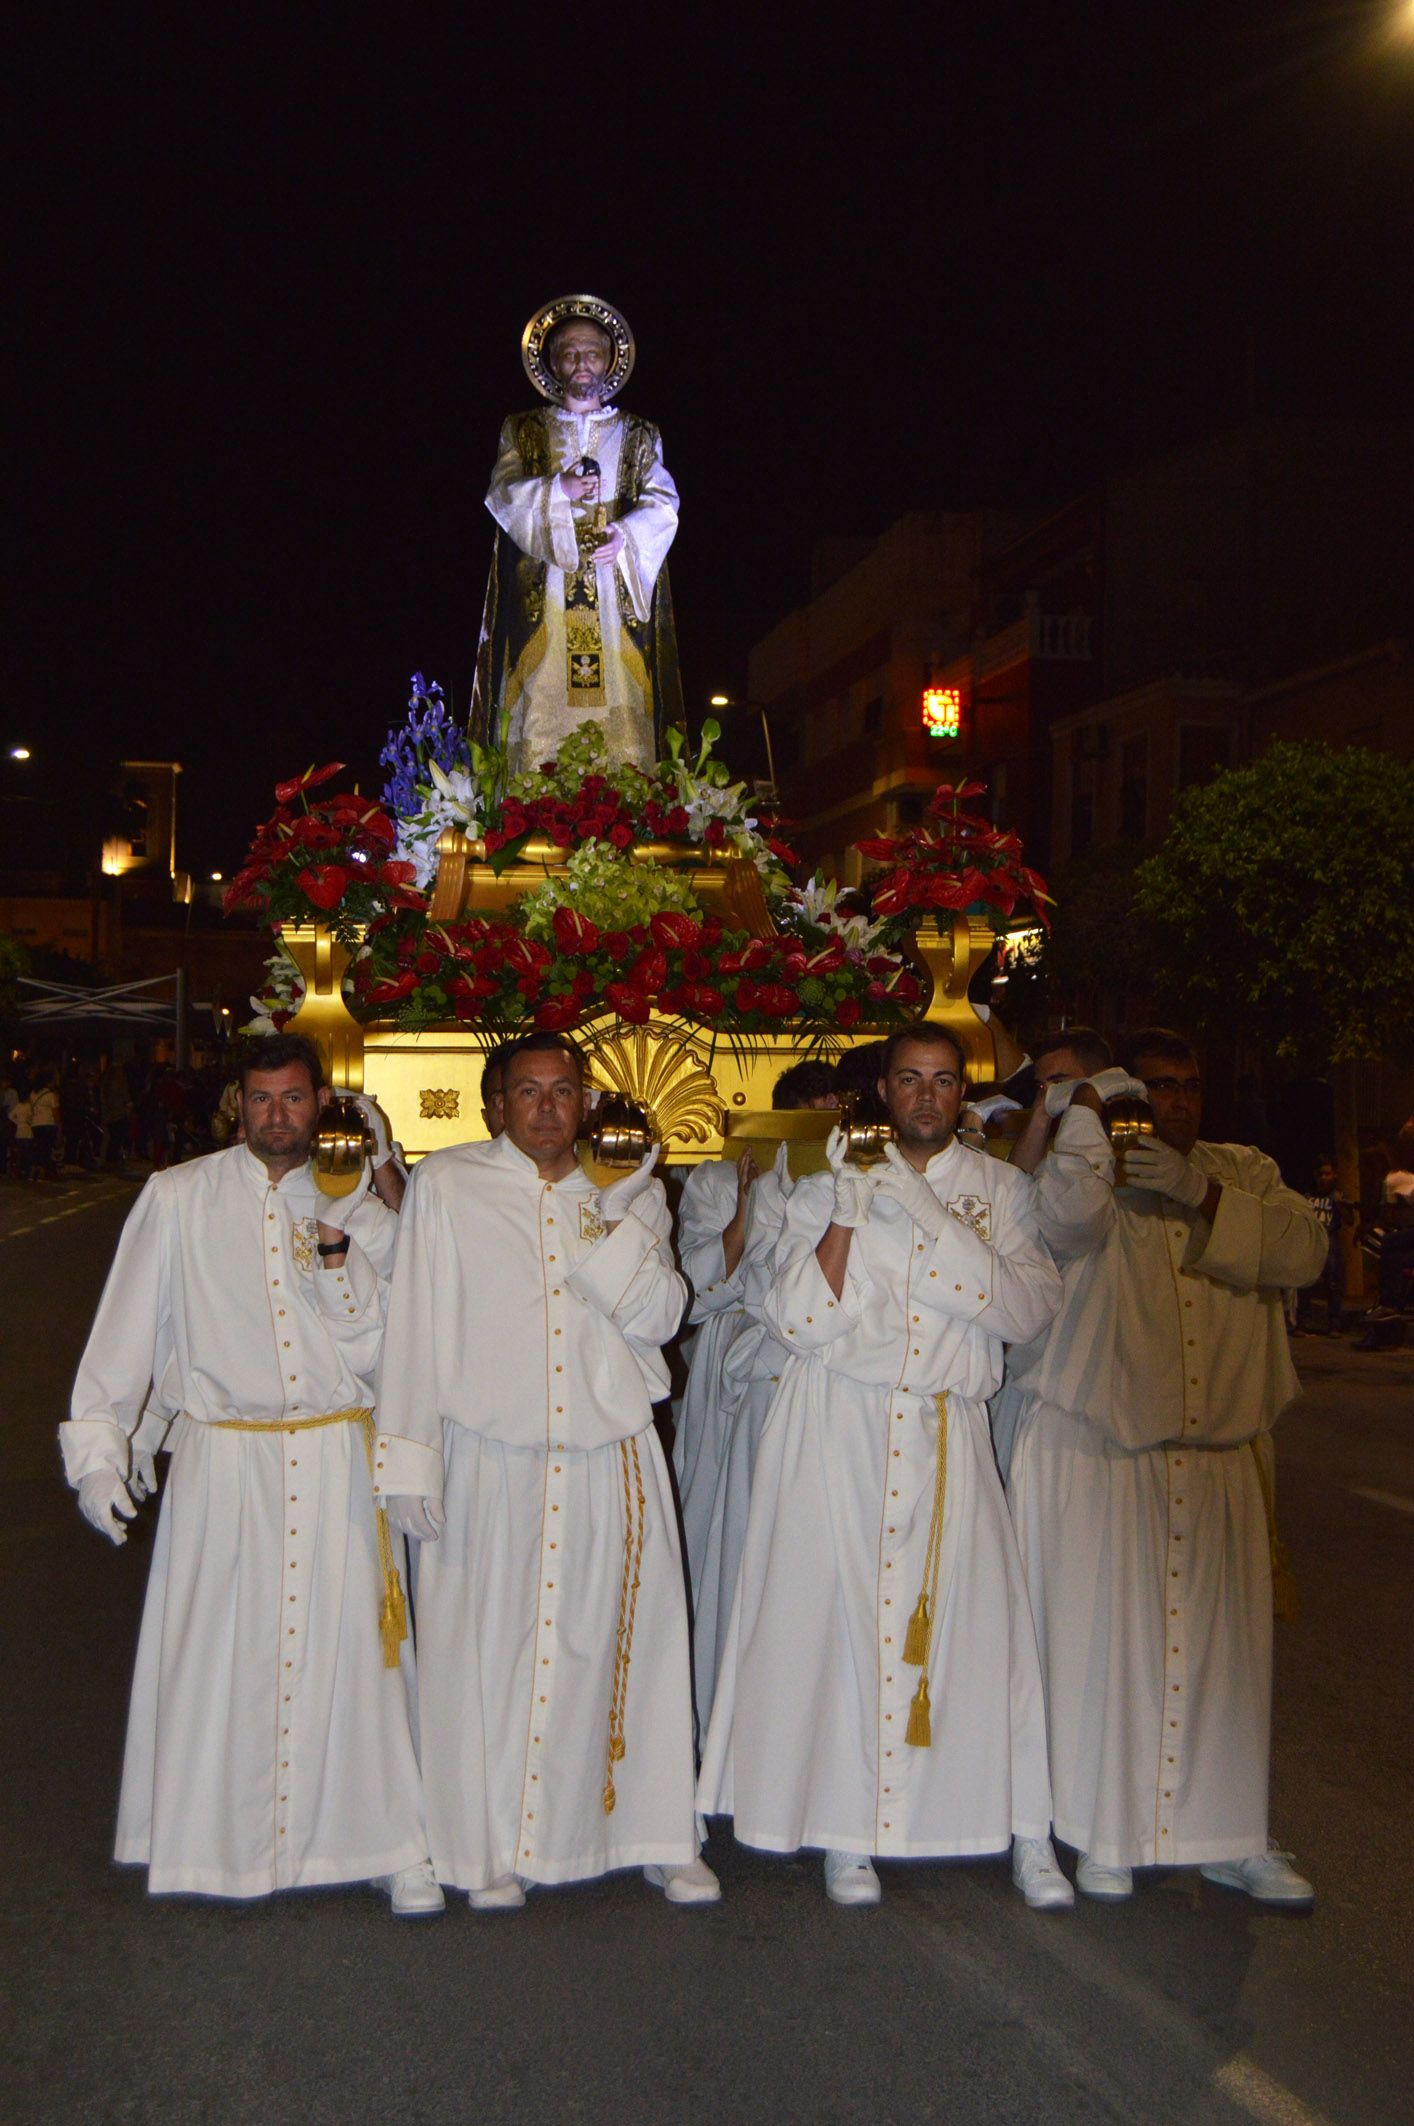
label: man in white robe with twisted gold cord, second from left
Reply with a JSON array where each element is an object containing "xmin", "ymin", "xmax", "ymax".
[{"xmin": 376, "ymin": 1033, "xmax": 719, "ymax": 1909}]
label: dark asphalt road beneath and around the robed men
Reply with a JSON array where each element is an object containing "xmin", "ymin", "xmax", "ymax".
[{"xmin": 0, "ymin": 1180, "xmax": 1414, "ymax": 2126}]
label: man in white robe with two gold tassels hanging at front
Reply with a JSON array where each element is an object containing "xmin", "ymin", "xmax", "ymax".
[{"xmin": 697, "ymin": 1025, "xmax": 1072, "ymax": 1907}]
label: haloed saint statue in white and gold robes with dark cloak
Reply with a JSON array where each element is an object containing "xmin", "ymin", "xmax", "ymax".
[{"xmin": 472, "ymin": 296, "xmax": 683, "ymax": 774}]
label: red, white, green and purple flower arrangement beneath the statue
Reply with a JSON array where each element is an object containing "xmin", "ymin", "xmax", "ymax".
[{"xmin": 225, "ymin": 674, "xmax": 1046, "ymax": 1044}]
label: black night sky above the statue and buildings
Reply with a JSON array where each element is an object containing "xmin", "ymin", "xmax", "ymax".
[{"xmin": 13, "ymin": 0, "xmax": 1414, "ymax": 874}]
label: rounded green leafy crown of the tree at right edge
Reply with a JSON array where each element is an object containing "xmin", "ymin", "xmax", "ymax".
[{"xmin": 1135, "ymin": 742, "xmax": 1414, "ymax": 1067}]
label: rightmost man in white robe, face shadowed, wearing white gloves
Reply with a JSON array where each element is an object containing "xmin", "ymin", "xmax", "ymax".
[{"xmin": 997, "ymin": 1029, "xmax": 1325, "ymax": 1907}]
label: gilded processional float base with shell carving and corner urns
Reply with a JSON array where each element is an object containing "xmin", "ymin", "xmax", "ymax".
[{"xmin": 281, "ymin": 827, "xmax": 997, "ymax": 1195}]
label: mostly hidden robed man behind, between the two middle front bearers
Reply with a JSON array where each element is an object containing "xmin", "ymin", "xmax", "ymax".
[{"xmin": 672, "ymin": 1061, "xmax": 840, "ymax": 1735}]
